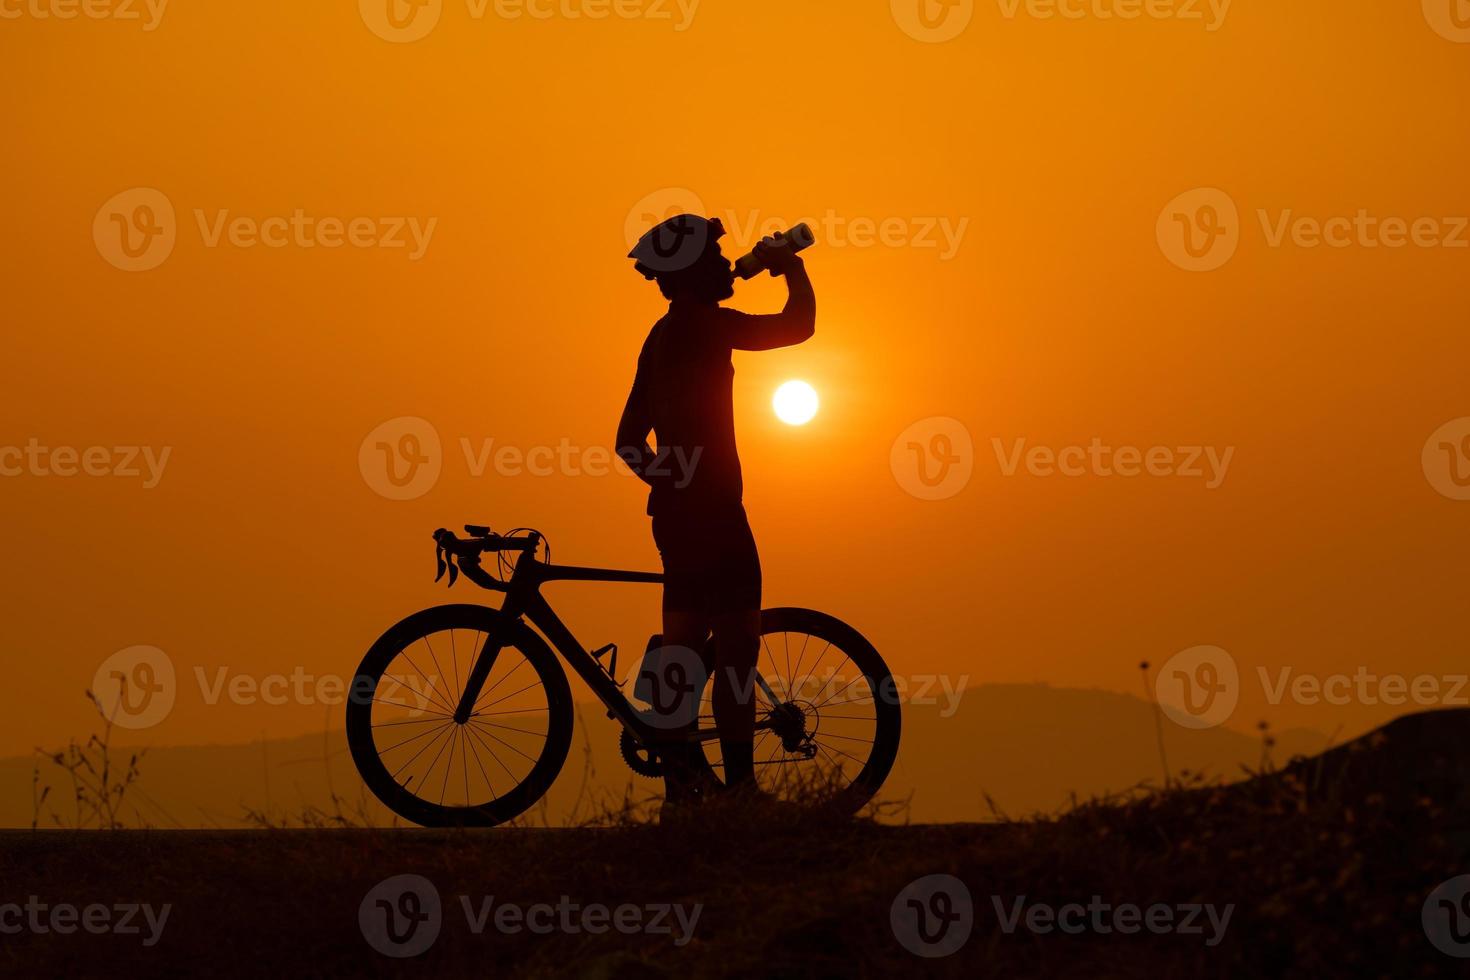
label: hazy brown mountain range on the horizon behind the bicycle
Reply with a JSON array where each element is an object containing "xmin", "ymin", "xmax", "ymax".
[{"xmin": 0, "ymin": 685, "xmax": 1327, "ymax": 827}]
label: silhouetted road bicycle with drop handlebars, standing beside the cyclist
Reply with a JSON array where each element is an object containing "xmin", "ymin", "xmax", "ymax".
[{"xmin": 347, "ymin": 525, "xmax": 901, "ymax": 827}]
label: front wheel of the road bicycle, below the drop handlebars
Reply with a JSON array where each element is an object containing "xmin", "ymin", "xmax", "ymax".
[{"xmin": 347, "ymin": 605, "xmax": 573, "ymax": 827}]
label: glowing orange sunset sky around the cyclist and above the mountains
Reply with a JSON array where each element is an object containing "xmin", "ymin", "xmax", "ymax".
[{"xmin": 0, "ymin": 0, "xmax": 1470, "ymax": 755}]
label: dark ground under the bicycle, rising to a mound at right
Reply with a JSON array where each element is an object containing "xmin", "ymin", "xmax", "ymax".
[{"xmin": 0, "ymin": 710, "xmax": 1470, "ymax": 980}]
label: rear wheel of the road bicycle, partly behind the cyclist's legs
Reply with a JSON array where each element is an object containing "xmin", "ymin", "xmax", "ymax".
[{"xmin": 700, "ymin": 608, "xmax": 903, "ymax": 813}]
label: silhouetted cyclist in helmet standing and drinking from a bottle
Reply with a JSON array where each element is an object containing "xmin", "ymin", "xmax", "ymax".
[{"xmin": 617, "ymin": 215, "xmax": 816, "ymax": 799}]
